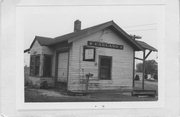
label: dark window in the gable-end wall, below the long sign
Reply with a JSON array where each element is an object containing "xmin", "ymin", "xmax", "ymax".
[{"xmin": 99, "ymin": 56, "xmax": 112, "ymax": 80}]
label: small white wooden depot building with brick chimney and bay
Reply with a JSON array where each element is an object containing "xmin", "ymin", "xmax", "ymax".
[{"xmin": 25, "ymin": 20, "xmax": 156, "ymax": 92}]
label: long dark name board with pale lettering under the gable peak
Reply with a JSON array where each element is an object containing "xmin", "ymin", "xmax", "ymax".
[{"xmin": 87, "ymin": 41, "xmax": 124, "ymax": 50}]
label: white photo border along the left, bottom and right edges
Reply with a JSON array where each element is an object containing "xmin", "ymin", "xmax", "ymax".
[{"xmin": 16, "ymin": 0, "xmax": 165, "ymax": 110}]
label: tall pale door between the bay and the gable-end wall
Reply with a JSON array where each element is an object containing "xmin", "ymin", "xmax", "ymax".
[{"xmin": 57, "ymin": 52, "xmax": 68, "ymax": 83}]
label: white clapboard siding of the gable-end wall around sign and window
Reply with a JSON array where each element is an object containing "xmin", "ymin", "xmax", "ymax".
[{"xmin": 68, "ymin": 29, "xmax": 133, "ymax": 90}]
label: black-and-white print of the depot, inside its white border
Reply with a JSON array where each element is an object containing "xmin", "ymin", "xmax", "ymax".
[{"xmin": 21, "ymin": 6, "xmax": 161, "ymax": 103}]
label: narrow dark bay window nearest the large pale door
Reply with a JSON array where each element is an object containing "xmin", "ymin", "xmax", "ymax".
[{"xmin": 43, "ymin": 55, "xmax": 52, "ymax": 77}]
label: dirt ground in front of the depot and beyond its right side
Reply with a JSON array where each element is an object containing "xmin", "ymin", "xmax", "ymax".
[{"xmin": 25, "ymin": 81, "xmax": 158, "ymax": 102}]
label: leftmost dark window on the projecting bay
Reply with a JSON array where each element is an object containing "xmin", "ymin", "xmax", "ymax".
[{"xmin": 30, "ymin": 55, "xmax": 40, "ymax": 76}]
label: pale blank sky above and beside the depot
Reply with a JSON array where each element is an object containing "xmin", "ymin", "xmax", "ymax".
[{"xmin": 20, "ymin": 6, "xmax": 163, "ymax": 65}]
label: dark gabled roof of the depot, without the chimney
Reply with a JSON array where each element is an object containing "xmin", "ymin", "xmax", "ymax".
[{"xmin": 26, "ymin": 21, "xmax": 156, "ymax": 51}]
